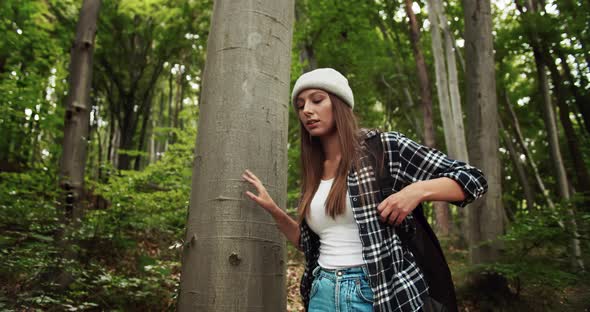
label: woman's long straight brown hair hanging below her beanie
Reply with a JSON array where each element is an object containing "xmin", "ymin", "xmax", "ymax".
[{"xmin": 298, "ymin": 93, "xmax": 360, "ymax": 221}]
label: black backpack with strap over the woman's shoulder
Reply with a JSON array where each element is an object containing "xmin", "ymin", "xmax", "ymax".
[{"xmin": 365, "ymin": 135, "xmax": 458, "ymax": 312}]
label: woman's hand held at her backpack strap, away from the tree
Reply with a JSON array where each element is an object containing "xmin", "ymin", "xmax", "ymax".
[{"xmin": 377, "ymin": 184, "xmax": 423, "ymax": 225}]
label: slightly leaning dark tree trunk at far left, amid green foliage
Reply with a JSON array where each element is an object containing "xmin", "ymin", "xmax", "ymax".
[{"xmin": 57, "ymin": 0, "xmax": 100, "ymax": 287}]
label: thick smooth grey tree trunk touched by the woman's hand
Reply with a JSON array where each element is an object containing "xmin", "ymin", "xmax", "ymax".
[{"xmin": 178, "ymin": 0, "xmax": 294, "ymax": 312}]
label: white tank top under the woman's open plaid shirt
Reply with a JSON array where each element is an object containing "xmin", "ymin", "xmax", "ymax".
[{"xmin": 306, "ymin": 179, "xmax": 364, "ymax": 269}]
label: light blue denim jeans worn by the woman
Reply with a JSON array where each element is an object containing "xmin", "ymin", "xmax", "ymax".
[{"xmin": 308, "ymin": 266, "xmax": 373, "ymax": 312}]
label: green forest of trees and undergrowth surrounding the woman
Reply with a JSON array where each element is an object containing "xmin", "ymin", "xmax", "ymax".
[{"xmin": 0, "ymin": 0, "xmax": 590, "ymax": 311}]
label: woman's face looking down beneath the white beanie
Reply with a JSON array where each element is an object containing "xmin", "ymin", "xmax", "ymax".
[{"xmin": 295, "ymin": 89, "xmax": 336, "ymax": 137}]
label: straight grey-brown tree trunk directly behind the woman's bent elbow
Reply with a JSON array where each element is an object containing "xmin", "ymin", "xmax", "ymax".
[{"xmin": 463, "ymin": 0, "xmax": 506, "ymax": 263}]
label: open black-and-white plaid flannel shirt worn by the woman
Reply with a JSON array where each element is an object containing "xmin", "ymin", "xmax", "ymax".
[{"xmin": 299, "ymin": 130, "xmax": 487, "ymax": 311}]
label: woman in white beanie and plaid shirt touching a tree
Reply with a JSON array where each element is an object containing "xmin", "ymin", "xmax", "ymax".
[{"xmin": 243, "ymin": 68, "xmax": 487, "ymax": 311}]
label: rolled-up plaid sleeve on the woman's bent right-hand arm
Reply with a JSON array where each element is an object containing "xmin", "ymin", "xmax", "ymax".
[{"xmin": 381, "ymin": 132, "xmax": 488, "ymax": 207}]
